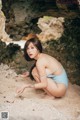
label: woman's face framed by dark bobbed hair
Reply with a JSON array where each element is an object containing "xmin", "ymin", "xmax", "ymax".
[{"xmin": 27, "ymin": 42, "xmax": 39, "ymax": 59}]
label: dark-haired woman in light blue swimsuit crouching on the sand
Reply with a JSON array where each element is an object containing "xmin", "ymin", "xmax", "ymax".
[{"xmin": 17, "ymin": 38, "xmax": 68, "ymax": 97}]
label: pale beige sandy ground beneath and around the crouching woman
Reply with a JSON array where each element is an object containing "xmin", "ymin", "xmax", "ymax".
[{"xmin": 0, "ymin": 64, "xmax": 80, "ymax": 120}]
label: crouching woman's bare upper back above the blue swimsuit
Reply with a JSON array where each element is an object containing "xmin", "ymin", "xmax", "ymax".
[{"xmin": 39, "ymin": 53, "xmax": 63, "ymax": 75}]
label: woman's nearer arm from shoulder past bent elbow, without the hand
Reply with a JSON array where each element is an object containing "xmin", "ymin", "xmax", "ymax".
[{"xmin": 34, "ymin": 59, "xmax": 47, "ymax": 89}]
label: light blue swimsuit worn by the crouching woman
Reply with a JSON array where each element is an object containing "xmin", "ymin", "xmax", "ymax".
[{"xmin": 47, "ymin": 69, "xmax": 68, "ymax": 87}]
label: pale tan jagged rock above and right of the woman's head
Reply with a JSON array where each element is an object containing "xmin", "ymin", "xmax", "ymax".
[{"xmin": 37, "ymin": 16, "xmax": 64, "ymax": 42}]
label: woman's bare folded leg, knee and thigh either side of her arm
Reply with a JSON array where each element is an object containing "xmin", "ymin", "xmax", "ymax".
[{"xmin": 32, "ymin": 67, "xmax": 66, "ymax": 97}]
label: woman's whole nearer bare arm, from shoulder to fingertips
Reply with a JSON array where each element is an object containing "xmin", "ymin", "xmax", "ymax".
[{"xmin": 17, "ymin": 60, "xmax": 47, "ymax": 93}]
